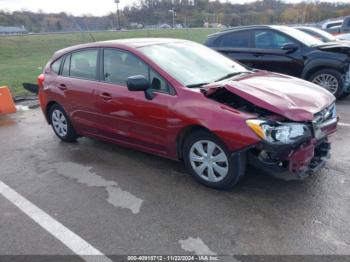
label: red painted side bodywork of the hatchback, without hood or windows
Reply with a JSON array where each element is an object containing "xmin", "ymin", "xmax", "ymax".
[{"xmin": 39, "ymin": 42, "xmax": 260, "ymax": 159}]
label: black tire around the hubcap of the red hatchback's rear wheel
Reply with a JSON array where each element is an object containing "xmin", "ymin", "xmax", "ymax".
[{"xmin": 49, "ymin": 104, "xmax": 79, "ymax": 142}]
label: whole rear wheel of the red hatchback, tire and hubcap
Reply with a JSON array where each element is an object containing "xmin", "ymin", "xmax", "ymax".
[{"xmin": 49, "ymin": 104, "xmax": 78, "ymax": 142}]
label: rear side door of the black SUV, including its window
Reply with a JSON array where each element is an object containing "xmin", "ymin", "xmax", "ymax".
[{"xmin": 212, "ymin": 30, "xmax": 255, "ymax": 67}]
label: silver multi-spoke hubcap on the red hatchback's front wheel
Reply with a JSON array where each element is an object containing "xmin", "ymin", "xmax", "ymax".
[{"xmin": 190, "ymin": 140, "xmax": 228, "ymax": 182}]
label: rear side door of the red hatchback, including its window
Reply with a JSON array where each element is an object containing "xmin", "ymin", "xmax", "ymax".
[{"xmin": 57, "ymin": 48, "xmax": 99, "ymax": 134}]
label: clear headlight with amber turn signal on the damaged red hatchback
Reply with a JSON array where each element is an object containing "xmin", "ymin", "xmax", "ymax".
[{"xmin": 246, "ymin": 119, "xmax": 311, "ymax": 144}]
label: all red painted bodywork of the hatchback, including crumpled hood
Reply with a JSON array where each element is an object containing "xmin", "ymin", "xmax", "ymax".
[{"xmin": 39, "ymin": 40, "xmax": 336, "ymax": 179}]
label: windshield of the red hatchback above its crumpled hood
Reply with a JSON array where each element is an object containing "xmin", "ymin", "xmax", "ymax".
[{"xmin": 139, "ymin": 42, "xmax": 249, "ymax": 87}]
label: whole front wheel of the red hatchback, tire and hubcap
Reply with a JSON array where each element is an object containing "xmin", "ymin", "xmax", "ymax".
[{"xmin": 183, "ymin": 130, "xmax": 246, "ymax": 189}]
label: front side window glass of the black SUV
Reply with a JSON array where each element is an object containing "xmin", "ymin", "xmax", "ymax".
[{"xmin": 254, "ymin": 30, "xmax": 296, "ymax": 49}]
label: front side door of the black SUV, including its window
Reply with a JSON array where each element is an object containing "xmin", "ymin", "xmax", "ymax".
[{"xmin": 253, "ymin": 29, "xmax": 304, "ymax": 76}]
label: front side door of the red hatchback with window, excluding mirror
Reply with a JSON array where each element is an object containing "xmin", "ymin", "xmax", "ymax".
[{"xmin": 98, "ymin": 48, "xmax": 175, "ymax": 154}]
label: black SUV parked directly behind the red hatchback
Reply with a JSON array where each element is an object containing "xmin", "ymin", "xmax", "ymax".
[{"xmin": 205, "ymin": 26, "xmax": 350, "ymax": 98}]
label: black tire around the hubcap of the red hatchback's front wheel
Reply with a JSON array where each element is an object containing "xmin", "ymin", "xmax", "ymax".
[{"xmin": 183, "ymin": 130, "xmax": 246, "ymax": 189}]
